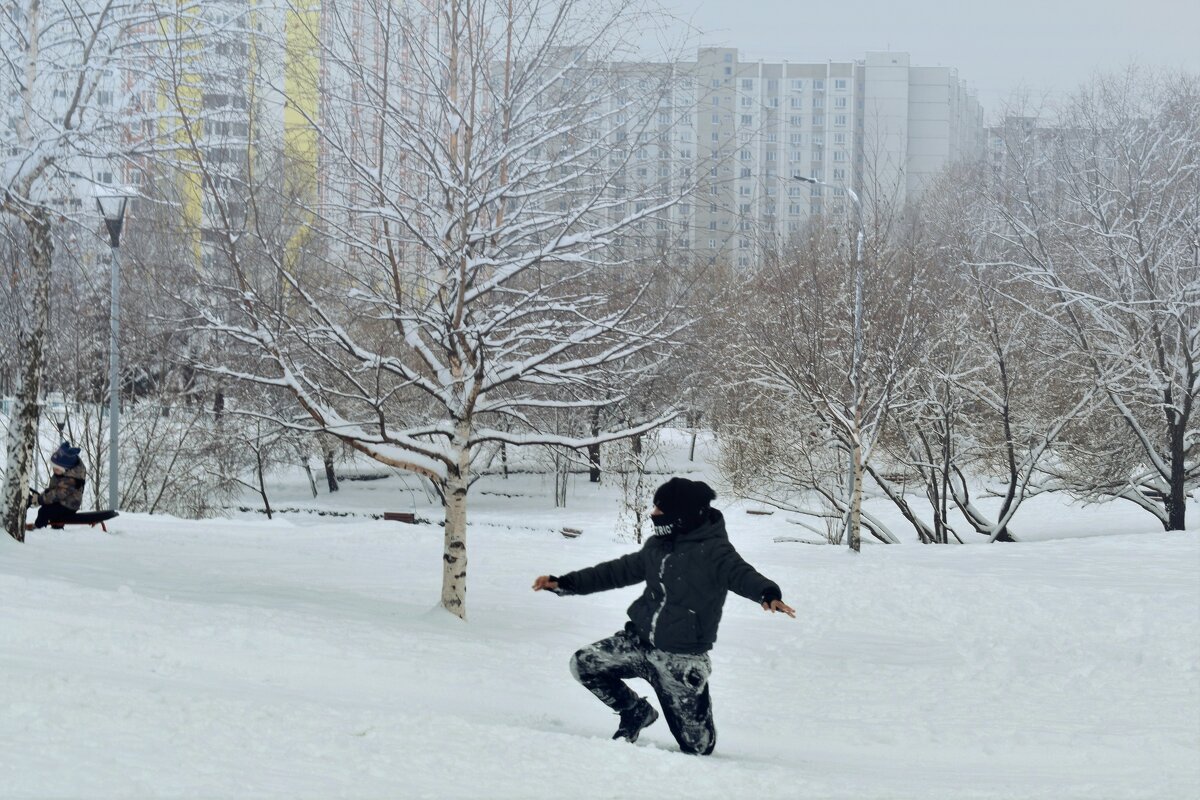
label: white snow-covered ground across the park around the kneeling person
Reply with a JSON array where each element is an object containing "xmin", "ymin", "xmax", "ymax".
[{"xmin": 0, "ymin": 434, "xmax": 1200, "ymax": 799}]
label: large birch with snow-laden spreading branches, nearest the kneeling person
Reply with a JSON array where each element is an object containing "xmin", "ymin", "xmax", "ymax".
[{"xmin": 187, "ymin": 0, "xmax": 692, "ymax": 618}]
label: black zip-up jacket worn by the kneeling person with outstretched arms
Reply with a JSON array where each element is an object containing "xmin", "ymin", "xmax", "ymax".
[{"xmin": 558, "ymin": 509, "xmax": 781, "ymax": 652}]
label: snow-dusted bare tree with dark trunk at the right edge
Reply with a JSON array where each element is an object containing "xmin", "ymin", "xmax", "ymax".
[{"xmin": 990, "ymin": 70, "xmax": 1200, "ymax": 530}]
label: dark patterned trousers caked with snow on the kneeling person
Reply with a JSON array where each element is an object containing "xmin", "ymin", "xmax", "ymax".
[{"xmin": 571, "ymin": 631, "xmax": 716, "ymax": 756}]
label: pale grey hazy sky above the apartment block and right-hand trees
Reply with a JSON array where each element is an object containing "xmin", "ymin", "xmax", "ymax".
[{"xmin": 664, "ymin": 0, "xmax": 1200, "ymax": 118}]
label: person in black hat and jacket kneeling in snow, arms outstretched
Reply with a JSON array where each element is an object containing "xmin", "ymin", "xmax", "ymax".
[{"xmin": 533, "ymin": 477, "xmax": 796, "ymax": 756}]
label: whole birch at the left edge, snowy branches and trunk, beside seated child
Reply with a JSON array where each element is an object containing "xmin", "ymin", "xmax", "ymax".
[{"xmin": 0, "ymin": 0, "xmax": 157, "ymax": 541}]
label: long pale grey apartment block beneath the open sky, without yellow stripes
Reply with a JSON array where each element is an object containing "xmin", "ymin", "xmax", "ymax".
[{"xmin": 673, "ymin": 48, "xmax": 984, "ymax": 266}]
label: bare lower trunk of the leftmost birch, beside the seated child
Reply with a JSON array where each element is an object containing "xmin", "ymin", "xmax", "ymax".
[{"xmin": 2, "ymin": 209, "xmax": 54, "ymax": 542}]
